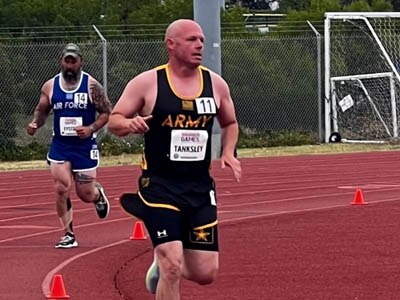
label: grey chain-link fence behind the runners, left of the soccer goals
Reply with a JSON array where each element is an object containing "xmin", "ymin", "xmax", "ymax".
[{"xmin": 0, "ymin": 36, "xmax": 320, "ymax": 149}]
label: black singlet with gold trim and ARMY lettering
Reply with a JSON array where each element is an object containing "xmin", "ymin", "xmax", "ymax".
[{"xmin": 142, "ymin": 65, "xmax": 218, "ymax": 180}]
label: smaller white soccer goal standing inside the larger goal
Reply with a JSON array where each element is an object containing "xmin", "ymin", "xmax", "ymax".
[{"xmin": 330, "ymin": 73, "xmax": 398, "ymax": 142}]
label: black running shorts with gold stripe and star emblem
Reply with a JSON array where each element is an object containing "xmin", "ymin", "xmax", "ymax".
[{"xmin": 121, "ymin": 177, "xmax": 218, "ymax": 251}]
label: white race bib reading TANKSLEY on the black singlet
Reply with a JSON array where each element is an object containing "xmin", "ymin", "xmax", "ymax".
[{"xmin": 170, "ymin": 129, "xmax": 208, "ymax": 161}]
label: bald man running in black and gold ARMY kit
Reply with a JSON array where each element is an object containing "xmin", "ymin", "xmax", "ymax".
[{"xmin": 108, "ymin": 20, "xmax": 241, "ymax": 300}]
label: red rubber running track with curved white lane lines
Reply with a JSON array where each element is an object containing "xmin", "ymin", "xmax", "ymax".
[{"xmin": 0, "ymin": 151, "xmax": 400, "ymax": 300}]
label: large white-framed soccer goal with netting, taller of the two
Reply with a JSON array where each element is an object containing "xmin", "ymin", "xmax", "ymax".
[{"xmin": 325, "ymin": 13, "xmax": 400, "ymax": 142}]
